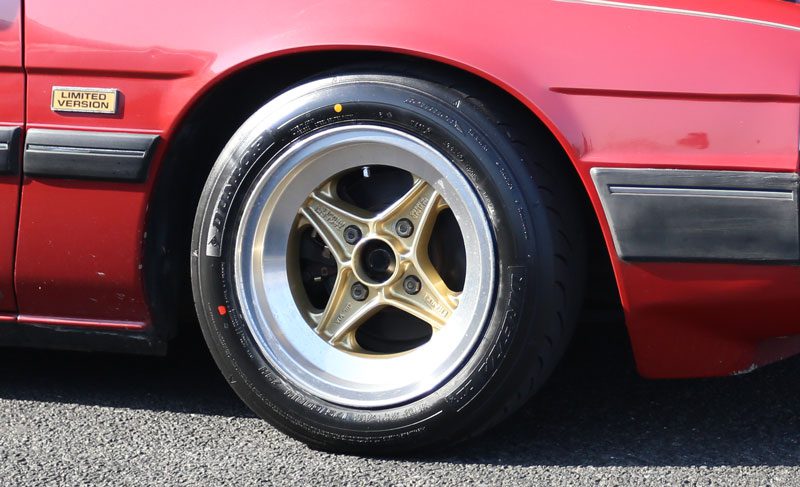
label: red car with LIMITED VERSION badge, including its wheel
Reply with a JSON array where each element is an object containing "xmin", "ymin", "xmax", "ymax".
[{"xmin": 0, "ymin": 0, "xmax": 800, "ymax": 453}]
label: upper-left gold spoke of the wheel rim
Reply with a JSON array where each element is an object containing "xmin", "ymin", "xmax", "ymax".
[{"xmin": 300, "ymin": 190, "xmax": 368, "ymax": 265}]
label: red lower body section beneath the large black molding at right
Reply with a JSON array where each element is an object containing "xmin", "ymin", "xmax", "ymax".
[{"xmin": 617, "ymin": 262, "xmax": 800, "ymax": 377}]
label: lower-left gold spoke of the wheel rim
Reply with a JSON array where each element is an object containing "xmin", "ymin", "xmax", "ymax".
[{"xmin": 315, "ymin": 268, "xmax": 378, "ymax": 343}]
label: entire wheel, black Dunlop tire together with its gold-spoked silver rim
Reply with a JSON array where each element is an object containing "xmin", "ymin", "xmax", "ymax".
[{"xmin": 191, "ymin": 73, "xmax": 591, "ymax": 455}]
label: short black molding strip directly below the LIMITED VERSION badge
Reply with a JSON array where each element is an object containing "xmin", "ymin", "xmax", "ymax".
[{"xmin": 23, "ymin": 129, "xmax": 158, "ymax": 182}]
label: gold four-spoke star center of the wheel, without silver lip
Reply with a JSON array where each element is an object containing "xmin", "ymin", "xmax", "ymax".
[{"xmin": 298, "ymin": 175, "xmax": 460, "ymax": 352}]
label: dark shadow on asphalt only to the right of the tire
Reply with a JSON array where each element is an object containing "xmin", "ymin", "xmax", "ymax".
[{"xmin": 440, "ymin": 324, "xmax": 800, "ymax": 467}]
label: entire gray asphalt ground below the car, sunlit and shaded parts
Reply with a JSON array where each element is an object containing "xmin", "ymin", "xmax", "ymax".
[{"xmin": 0, "ymin": 327, "xmax": 800, "ymax": 486}]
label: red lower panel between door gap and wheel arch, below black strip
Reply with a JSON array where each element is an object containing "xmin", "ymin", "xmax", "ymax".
[{"xmin": 17, "ymin": 178, "xmax": 153, "ymax": 321}]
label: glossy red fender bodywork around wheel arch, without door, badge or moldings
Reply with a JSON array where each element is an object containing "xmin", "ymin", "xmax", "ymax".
[{"xmin": 9, "ymin": 0, "xmax": 800, "ymax": 377}]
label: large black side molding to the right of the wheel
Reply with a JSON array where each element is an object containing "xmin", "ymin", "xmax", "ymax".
[{"xmin": 591, "ymin": 168, "xmax": 800, "ymax": 263}]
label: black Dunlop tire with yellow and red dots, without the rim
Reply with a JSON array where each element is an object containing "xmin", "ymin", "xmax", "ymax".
[{"xmin": 192, "ymin": 75, "xmax": 552, "ymax": 452}]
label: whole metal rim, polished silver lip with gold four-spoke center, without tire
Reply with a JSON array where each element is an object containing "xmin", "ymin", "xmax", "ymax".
[{"xmin": 233, "ymin": 125, "xmax": 496, "ymax": 407}]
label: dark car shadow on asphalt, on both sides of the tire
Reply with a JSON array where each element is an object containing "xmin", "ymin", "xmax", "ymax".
[{"xmin": 0, "ymin": 325, "xmax": 800, "ymax": 467}]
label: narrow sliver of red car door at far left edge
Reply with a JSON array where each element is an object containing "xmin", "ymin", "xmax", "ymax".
[{"xmin": 0, "ymin": 0, "xmax": 25, "ymax": 312}]
